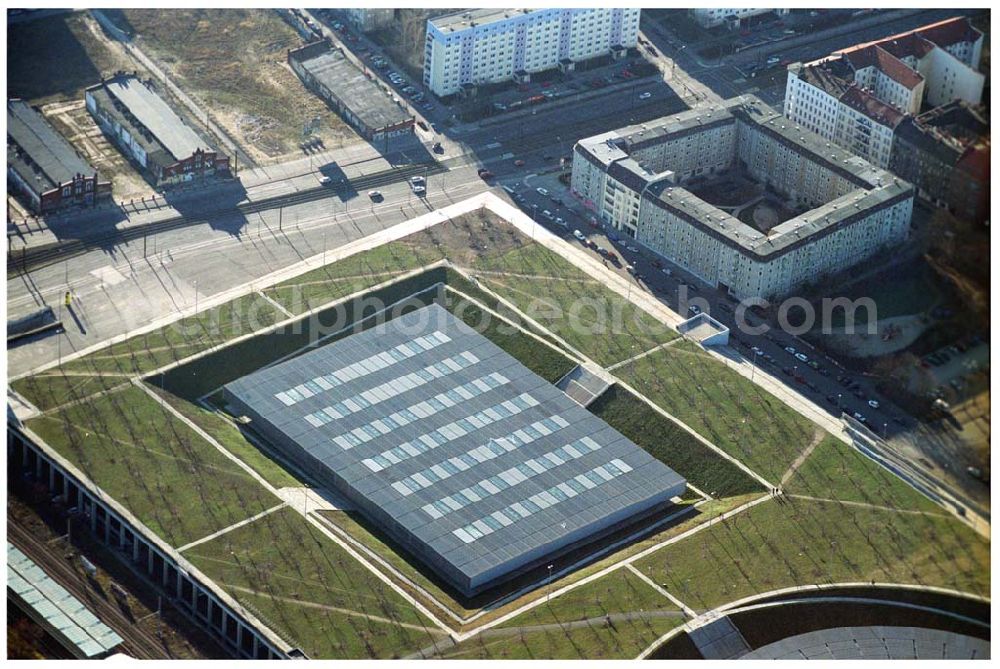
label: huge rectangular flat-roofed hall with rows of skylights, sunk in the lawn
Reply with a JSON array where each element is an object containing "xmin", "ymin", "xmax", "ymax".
[{"xmin": 225, "ymin": 305, "xmax": 686, "ymax": 595}]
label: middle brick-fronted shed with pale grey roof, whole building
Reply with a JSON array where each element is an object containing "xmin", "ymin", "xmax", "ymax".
[{"xmin": 86, "ymin": 73, "xmax": 229, "ymax": 186}]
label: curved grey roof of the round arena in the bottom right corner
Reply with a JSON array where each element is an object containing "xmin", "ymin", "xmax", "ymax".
[{"xmin": 740, "ymin": 626, "xmax": 990, "ymax": 660}]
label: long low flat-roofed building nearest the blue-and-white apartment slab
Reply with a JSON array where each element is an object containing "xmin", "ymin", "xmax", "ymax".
[{"xmin": 288, "ymin": 39, "xmax": 413, "ymax": 141}]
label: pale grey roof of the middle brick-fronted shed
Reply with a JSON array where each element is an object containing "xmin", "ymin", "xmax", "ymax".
[{"xmin": 104, "ymin": 76, "xmax": 211, "ymax": 160}]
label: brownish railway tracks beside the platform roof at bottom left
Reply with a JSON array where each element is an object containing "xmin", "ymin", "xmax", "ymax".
[{"xmin": 7, "ymin": 516, "xmax": 176, "ymax": 660}]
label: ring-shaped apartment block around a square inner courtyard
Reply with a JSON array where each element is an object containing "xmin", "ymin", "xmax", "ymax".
[{"xmin": 571, "ymin": 96, "xmax": 913, "ymax": 299}]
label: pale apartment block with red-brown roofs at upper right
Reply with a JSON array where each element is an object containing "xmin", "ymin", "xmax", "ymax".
[{"xmin": 783, "ymin": 17, "xmax": 985, "ymax": 168}]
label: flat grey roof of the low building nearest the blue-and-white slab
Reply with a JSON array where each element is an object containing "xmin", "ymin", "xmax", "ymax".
[{"xmin": 291, "ymin": 42, "xmax": 413, "ymax": 130}]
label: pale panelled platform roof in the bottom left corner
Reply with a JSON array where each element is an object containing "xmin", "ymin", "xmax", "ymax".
[{"xmin": 7, "ymin": 542, "xmax": 122, "ymax": 658}]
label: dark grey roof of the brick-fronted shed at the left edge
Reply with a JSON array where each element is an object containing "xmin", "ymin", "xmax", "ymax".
[{"xmin": 7, "ymin": 100, "xmax": 95, "ymax": 193}]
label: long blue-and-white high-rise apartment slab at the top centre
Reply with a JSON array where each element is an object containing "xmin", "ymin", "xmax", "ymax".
[{"xmin": 424, "ymin": 7, "xmax": 641, "ymax": 97}]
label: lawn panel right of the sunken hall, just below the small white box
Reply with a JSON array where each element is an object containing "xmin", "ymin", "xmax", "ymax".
[{"xmin": 616, "ymin": 341, "xmax": 817, "ymax": 480}]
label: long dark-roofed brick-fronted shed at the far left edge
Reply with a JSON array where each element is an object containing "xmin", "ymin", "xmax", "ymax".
[{"xmin": 7, "ymin": 100, "xmax": 111, "ymax": 214}]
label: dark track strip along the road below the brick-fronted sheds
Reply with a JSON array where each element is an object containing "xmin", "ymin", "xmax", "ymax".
[{"xmin": 7, "ymin": 163, "xmax": 448, "ymax": 278}]
